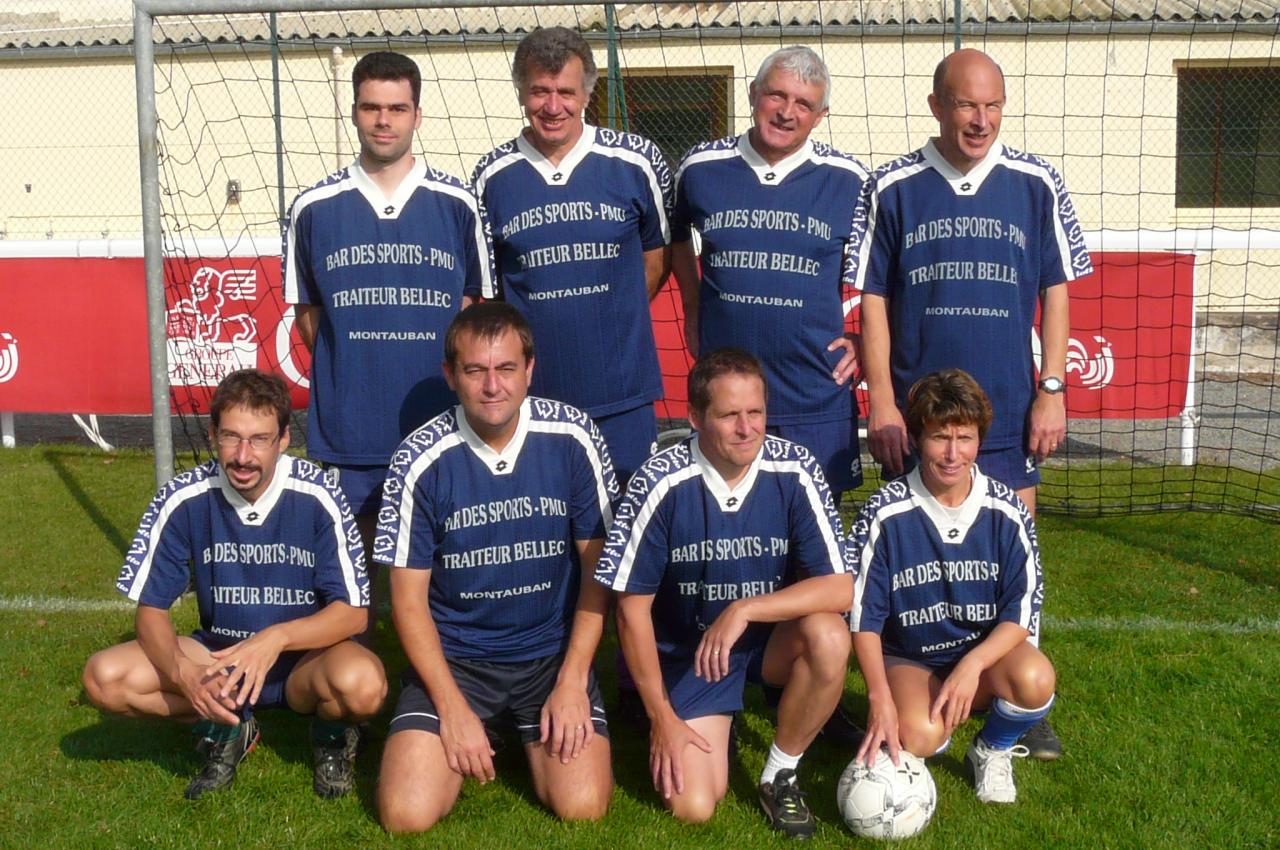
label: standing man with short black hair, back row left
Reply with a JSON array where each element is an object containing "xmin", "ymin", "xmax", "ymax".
[{"xmin": 284, "ymin": 51, "xmax": 493, "ymax": 583}]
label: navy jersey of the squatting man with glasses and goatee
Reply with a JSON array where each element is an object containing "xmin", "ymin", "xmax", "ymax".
[{"xmin": 115, "ymin": 454, "xmax": 369, "ymax": 648}]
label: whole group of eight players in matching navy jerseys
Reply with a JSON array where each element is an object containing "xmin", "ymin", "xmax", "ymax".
[{"xmin": 84, "ymin": 27, "xmax": 1070, "ymax": 838}]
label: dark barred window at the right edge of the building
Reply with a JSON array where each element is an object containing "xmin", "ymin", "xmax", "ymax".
[{"xmin": 1176, "ymin": 67, "xmax": 1280, "ymax": 207}]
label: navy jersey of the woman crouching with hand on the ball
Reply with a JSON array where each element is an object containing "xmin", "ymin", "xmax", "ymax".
[{"xmin": 849, "ymin": 467, "xmax": 1044, "ymax": 667}]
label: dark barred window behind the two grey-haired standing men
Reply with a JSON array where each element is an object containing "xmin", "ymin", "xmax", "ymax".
[{"xmin": 586, "ymin": 68, "xmax": 733, "ymax": 172}]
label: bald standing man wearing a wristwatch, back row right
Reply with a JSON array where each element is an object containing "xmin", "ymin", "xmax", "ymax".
[{"xmin": 846, "ymin": 50, "xmax": 1093, "ymax": 759}]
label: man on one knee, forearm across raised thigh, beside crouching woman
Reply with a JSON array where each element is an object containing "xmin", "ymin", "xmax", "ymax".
[{"xmin": 595, "ymin": 348, "xmax": 852, "ymax": 837}]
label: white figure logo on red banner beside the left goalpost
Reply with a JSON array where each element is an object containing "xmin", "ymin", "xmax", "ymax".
[{"xmin": 165, "ymin": 266, "xmax": 257, "ymax": 387}]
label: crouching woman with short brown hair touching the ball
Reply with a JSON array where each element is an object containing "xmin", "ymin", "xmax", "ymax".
[{"xmin": 850, "ymin": 369, "xmax": 1055, "ymax": 803}]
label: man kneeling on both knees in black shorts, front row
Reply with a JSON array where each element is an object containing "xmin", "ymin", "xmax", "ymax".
[{"xmin": 374, "ymin": 301, "xmax": 617, "ymax": 832}]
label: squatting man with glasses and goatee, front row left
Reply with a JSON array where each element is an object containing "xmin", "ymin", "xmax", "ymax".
[{"xmin": 84, "ymin": 369, "xmax": 387, "ymax": 800}]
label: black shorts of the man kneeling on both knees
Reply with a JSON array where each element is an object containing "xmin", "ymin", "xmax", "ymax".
[{"xmin": 387, "ymin": 655, "xmax": 609, "ymax": 744}]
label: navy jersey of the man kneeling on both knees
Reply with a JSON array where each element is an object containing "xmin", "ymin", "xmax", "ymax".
[{"xmin": 374, "ymin": 397, "xmax": 618, "ymax": 662}]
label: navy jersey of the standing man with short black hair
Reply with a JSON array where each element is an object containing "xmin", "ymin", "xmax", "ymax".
[{"xmin": 284, "ymin": 161, "xmax": 493, "ymax": 465}]
